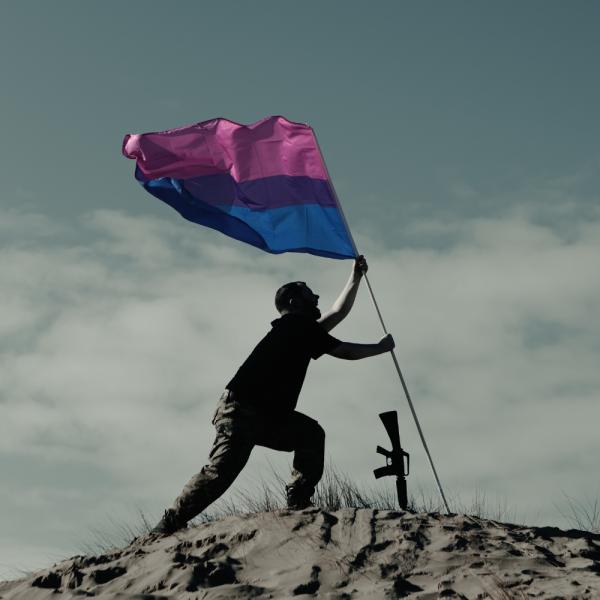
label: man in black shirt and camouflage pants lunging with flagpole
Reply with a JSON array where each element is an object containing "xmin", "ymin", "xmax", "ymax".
[{"xmin": 152, "ymin": 256, "xmax": 394, "ymax": 535}]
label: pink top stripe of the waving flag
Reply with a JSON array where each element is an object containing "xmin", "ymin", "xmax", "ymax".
[{"xmin": 123, "ymin": 116, "xmax": 327, "ymax": 182}]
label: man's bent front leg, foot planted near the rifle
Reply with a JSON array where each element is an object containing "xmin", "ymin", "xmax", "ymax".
[{"xmin": 256, "ymin": 411, "xmax": 325, "ymax": 508}]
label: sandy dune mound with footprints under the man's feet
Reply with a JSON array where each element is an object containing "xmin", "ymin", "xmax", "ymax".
[{"xmin": 0, "ymin": 508, "xmax": 600, "ymax": 600}]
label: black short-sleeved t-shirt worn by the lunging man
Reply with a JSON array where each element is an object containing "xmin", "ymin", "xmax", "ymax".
[{"xmin": 226, "ymin": 314, "xmax": 340, "ymax": 414}]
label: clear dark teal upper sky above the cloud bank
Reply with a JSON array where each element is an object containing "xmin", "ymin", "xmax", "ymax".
[{"xmin": 0, "ymin": 0, "xmax": 600, "ymax": 234}]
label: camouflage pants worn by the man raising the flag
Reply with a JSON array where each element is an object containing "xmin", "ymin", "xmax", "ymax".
[{"xmin": 174, "ymin": 390, "xmax": 325, "ymax": 521}]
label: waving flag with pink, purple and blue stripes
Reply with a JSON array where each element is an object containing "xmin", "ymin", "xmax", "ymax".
[{"xmin": 123, "ymin": 116, "xmax": 357, "ymax": 258}]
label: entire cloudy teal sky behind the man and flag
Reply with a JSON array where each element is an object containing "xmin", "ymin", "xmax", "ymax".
[{"xmin": 0, "ymin": 0, "xmax": 600, "ymax": 578}]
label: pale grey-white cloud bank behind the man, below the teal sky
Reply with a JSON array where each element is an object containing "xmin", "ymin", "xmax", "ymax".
[{"xmin": 0, "ymin": 205, "xmax": 600, "ymax": 576}]
